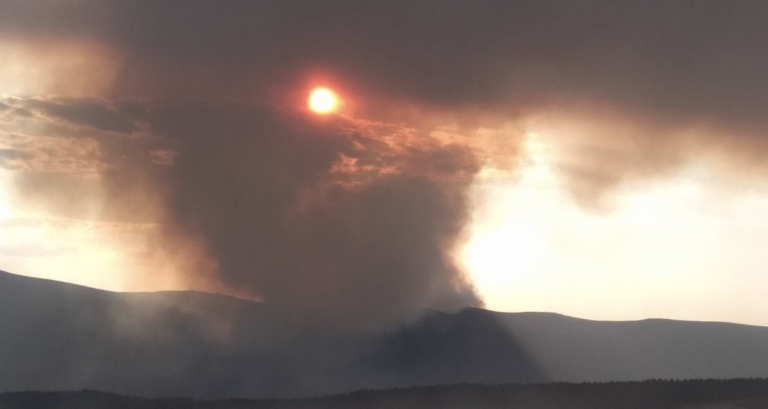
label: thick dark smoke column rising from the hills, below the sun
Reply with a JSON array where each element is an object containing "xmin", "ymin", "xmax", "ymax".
[{"xmin": 149, "ymin": 104, "xmax": 479, "ymax": 325}]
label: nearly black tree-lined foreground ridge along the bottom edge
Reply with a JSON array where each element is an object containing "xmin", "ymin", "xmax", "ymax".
[{"xmin": 0, "ymin": 379, "xmax": 768, "ymax": 409}]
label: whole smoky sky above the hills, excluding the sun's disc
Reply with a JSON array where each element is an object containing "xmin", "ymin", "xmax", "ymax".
[{"xmin": 0, "ymin": 0, "xmax": 768, "ymax": 327}]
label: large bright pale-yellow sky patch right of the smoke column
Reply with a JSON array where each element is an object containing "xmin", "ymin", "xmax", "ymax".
[{"xmin": 460, "ymin": 133, "xmax": 768, "ymax": 325}]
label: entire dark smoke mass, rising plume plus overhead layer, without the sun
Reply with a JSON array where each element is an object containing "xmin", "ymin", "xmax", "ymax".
[{"xmin": 0, "ymin": 0, "xmax": 768, "ymax": 323}]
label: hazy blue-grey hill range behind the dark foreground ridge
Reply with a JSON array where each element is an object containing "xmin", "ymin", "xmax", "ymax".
[{"xmin": 0, "ymin": 272, "xmax": 768, "ymax": 399}]
